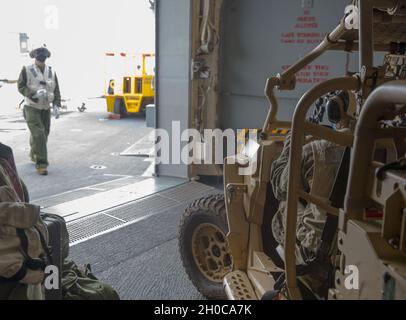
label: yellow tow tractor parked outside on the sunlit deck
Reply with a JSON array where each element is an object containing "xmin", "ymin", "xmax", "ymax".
[{"xmin": 105, "ymin": 54, "xmax": 155, "ymax": 116}]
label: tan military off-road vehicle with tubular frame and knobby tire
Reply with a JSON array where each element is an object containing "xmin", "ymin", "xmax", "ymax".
[{"xmin": 179, "ymin": 0, "xmax": 406, "ymax": 300}]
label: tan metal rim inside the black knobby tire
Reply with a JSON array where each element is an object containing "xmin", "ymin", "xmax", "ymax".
[{"xmin": 192, "ymin": 223, "xmax": 233, "ymax": 283}]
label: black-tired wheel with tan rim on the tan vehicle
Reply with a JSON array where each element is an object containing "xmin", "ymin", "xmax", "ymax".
[{"xmin": 179, "ymin": 195, "xmax": 233, "ymax": 299}]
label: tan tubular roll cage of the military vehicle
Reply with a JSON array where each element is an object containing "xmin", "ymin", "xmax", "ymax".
[{"xmin": 262, "ymin": 0, "xmax": 406, "ymax": 299}]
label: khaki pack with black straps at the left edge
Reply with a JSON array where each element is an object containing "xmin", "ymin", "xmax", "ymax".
[{"xmin": 0, "ymin": 143, "xmax": 49, "ymax": 300}]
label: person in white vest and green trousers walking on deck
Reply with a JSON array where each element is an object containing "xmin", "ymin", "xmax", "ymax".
[{"xmin": 18, "ymin": 47, "xmax": 61, "ymax": 175}]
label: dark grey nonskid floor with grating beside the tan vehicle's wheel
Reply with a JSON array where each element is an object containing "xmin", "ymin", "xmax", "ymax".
[{"xmin": 63, "ymin": 182, "xmax": 219, "ymax": 299}]
